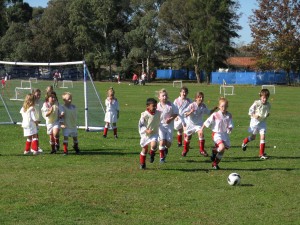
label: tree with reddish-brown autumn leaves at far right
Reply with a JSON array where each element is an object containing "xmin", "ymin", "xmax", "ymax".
[{"xmin": 250, "ymin": 0, "xmax": 300, "ymax": 83}]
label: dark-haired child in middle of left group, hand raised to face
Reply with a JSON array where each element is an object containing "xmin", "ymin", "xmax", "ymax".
[{"xmin": 42, "ymin": 91, "xmax": 60, "ymax": 154}]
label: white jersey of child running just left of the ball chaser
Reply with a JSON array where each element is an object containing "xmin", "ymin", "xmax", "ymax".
[{"xmin": 187, "ymin": 102, "xmax": 210, "ymax": 126}]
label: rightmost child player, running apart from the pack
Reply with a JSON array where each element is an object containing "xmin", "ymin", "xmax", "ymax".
[{"xmin": 242, "ymin": 89, "xmax": 271, "ymax": 159}]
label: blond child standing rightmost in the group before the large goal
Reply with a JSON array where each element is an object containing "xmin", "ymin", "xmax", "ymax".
[{"xmin": 61, "ymin": 92, "xmax": 80, "ymax": 155}]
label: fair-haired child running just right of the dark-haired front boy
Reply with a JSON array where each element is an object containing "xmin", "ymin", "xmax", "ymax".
[{"xmin": 157, "ymin": 89, "xmax": 178, "ymax": 163}]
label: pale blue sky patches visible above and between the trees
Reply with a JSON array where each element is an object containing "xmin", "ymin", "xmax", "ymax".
[{"xmin": 24, "ymin": 0, "xmax": 257, "ymax": 44}]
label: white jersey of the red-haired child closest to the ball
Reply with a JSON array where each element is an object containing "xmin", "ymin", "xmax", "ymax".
[{"xmin": 204, "ymin": 111, "xmax": 233, "ymax": 133}]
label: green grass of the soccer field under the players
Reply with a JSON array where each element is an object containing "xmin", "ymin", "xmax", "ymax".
[{"xmin": 0, "ymin": 83, "xmax": 300, "ymax": 225}]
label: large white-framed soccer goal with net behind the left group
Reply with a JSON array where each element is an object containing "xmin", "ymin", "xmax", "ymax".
[{"xmin": 0, "ymin": 61, "xmax": 105, "ymax": 131}]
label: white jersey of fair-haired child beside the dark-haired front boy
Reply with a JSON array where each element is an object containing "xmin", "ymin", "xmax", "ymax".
[{"xmin": 157, "ymin": 101, "xmax": 178, "ymax": 127}]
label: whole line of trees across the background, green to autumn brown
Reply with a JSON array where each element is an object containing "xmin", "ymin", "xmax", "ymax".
[{"xmin": 0, "ymin": 0, "xmax": 300, "ymax": 82}]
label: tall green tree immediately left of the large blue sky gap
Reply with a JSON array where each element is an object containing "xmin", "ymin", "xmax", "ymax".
[{"xmin": 160, "ymin": 0, "xmax": 240, "ymax": 82}]
